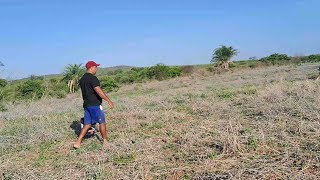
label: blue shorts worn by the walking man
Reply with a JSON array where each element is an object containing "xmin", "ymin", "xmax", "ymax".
[{"xmin": 83, "ymin": 105, "xmax": 106, "ymax": 124}]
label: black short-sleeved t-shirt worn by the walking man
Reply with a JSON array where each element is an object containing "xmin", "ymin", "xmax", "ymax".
[{"xmin": 80, "ymin": 73, "xmax": 102, "ymax": 107}]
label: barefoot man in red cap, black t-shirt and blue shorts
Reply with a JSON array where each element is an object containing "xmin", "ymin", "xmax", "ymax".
[{"xmin": 73, "ymin": 61, "xmax": 114, "ymax": 148}]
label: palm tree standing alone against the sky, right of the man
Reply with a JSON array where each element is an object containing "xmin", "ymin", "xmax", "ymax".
[{"xmin": 211, "ymin": 45, "xmax": 238, "ymax": 69}]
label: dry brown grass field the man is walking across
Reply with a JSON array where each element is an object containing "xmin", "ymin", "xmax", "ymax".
[{"xmin": 0, "ymin": 64, "xmax": 320, "ymax": 179}]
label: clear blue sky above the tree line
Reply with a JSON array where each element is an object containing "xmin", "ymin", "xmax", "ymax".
[{"xmin": 0, "ymin": 0, "xmax": 320, "ymax": 79}]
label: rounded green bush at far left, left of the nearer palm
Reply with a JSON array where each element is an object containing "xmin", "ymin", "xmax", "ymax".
[{"xmin": 17, "ymin": 80, "xmax": 45, "ymax": 99}]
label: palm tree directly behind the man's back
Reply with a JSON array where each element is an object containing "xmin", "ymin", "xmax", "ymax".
[{"xmin": 63, "ymin": 64, "xmax": 85, "ymax": 93}]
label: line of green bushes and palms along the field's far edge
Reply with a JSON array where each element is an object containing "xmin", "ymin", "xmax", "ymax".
[{"xmin": 0, "ymin": 45, "xmax": 320, "ymax": 107}]
